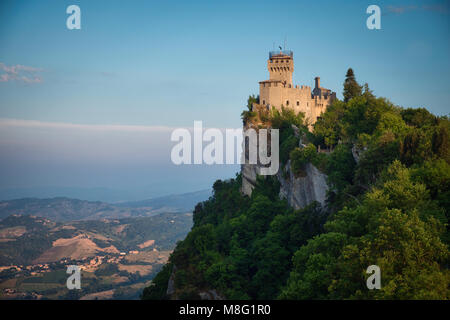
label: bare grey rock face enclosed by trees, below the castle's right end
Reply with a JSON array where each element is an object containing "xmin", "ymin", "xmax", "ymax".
[{"xmin": 277, "ymin": 161, "xmax": 328, "ymax": 209}]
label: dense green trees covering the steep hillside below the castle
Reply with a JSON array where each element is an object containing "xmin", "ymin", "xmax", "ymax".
[{"xmin": 142, "ymin": 72, "xmax": 450, "ymax": 299}]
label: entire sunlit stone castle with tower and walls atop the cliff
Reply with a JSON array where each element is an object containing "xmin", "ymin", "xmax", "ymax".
[{"xmin": 253, "ymin": 50, "xmax": 336, "ymax": 125}]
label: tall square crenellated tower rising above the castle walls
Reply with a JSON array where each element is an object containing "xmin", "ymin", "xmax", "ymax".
[{"xmin": 267, "ymin": 51, "xmax": 294, "ymax": 85}]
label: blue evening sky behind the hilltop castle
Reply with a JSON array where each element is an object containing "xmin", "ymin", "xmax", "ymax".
[{"xmin": 0, "ymin": 0, "xmax": 450, "ymax": 200}]
